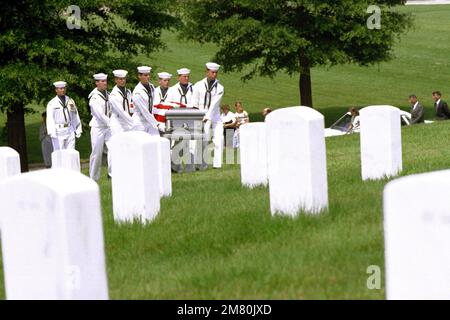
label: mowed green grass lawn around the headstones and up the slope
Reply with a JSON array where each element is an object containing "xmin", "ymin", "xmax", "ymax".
[{"xmin": 0, "ymin": 6, "xmax": 450, "ymax": 299}]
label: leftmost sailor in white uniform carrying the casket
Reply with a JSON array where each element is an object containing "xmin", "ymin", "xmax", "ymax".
[{"xmin": 89, "ymin": 73, "xmax": 111, "ymax": 181}]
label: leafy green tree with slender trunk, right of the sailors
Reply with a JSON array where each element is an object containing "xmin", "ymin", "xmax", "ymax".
[{"xmin": 180, "ymin": 0, "xmax": 412, "ymax": 107}]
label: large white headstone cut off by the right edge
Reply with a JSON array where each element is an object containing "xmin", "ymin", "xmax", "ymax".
[{"xmin": 384, "ymin": 170, "xmax": 450, "ymax": 300}]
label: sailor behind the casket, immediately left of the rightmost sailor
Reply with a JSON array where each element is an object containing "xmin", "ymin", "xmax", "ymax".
[{"xmin": 167, "ymin": 68, "xmax": 195, "ymax": 173}]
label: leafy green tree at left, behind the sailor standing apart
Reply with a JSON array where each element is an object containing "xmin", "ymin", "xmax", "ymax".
[{"xmin": 0, "ymin": 0, "xmax": 176, "ymax": 171}]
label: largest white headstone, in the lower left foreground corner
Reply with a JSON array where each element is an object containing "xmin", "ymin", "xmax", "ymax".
[{"xmin": 0, "ymin": 169, "xmax": 108, "ymax": 300}]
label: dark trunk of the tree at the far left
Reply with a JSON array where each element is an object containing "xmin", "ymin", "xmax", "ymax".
[{"xmin": 7, "ymin": 104, "xmax": 28, "ymax": 172}]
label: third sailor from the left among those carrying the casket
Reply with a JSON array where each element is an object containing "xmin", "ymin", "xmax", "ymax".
[{"xmin": 133, "ymin": 66, "xmax": 159, "ymax": 136}]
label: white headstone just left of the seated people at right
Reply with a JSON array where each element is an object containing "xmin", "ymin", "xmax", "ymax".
[{"xmin": 360, "ymin": 106, "xmax": 402, "ymax": 180}]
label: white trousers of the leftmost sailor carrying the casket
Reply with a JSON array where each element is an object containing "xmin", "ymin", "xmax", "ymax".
[{"xmin": 89, "ymin": 127, "xmax": 111, "ymax": 181}]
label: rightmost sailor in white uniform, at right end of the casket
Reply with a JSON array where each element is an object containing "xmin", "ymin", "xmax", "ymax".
[{"xmin": 192, "ymin": 62, "xmax": 224, "ymax": 170}]
